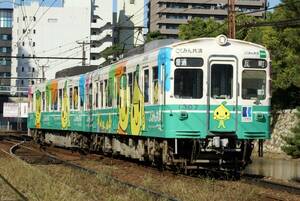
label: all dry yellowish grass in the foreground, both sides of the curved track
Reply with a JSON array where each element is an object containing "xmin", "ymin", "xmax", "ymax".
[{"xmin": 0, "ymin": 154, "xmax": 297, "ymax": 201}]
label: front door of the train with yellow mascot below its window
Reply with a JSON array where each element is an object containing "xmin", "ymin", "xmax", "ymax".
[{"xmin": 207, "ymin": 58, "xmax": 238, "ymax": 133}]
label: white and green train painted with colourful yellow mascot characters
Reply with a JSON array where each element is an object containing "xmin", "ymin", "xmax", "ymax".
[{"xmin": 28, "ymin": 35, "xmax": 271, "ymax": 172}]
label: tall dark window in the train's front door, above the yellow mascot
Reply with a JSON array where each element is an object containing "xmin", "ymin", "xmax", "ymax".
[{"xmin": 211, "ymin": 64, "xmax": 233, "ymax": 99}]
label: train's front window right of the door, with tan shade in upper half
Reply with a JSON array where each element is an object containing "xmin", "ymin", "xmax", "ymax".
[{"xmin": 242, "ymin": 70, "xmax": 266, "ymax": 100}]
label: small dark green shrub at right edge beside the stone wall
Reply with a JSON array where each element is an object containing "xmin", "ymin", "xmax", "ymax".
[{"xmin": 282, "ymin": 107, "xmax": 300, "ymax": 158}]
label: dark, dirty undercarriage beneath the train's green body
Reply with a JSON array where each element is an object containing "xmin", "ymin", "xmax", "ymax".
[{"xmin": 29, "ymin": 129, "xmax": 253, "ymax": 175}]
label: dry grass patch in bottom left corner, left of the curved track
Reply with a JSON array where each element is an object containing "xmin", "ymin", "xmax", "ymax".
[{"xmin": 0, "ymin": 153, "xmax": 164, "ymax": 201}]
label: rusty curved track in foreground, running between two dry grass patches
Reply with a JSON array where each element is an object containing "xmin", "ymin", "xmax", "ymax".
[{"xmin": 10, "ymin": 142, "xmax": 180, "ymax": 201}]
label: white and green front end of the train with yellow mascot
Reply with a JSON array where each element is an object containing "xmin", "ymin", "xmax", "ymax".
[{"xmin": 164, "ymin": 35, "xmax": 271, "ymax": 170}]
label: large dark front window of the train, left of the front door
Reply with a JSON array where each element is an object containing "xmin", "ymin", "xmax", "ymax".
[{"xmin": 174, "ymin": 69, "xmax": 203, "ymax": 99}]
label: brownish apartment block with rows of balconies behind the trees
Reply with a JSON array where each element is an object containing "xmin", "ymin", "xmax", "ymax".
[{"xmin": 148, "ymin": 0, "xmax": 267, "ymax": 38}]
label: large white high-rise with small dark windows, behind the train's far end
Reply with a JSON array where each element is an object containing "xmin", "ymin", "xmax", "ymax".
[{"xmin": 11, "ymin": 0, "xmax": 112, "ymax": 87}]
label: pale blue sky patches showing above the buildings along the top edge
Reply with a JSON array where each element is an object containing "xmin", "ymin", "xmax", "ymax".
[{"xmin": 0, "ymin": 0, "xmax": 281, "ymax": 8}]
